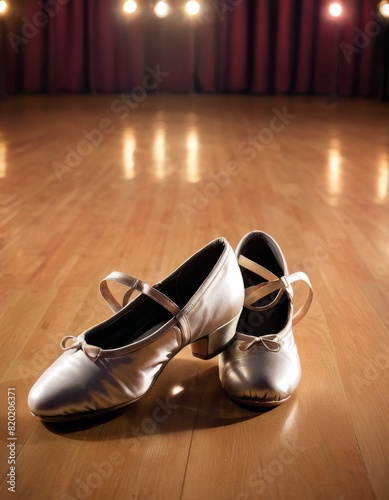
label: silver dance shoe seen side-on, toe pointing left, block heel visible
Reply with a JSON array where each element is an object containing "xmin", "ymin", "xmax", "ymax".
[{"xmin": 28, "ymin": 238, "xmax": 244, "ymax": 422}]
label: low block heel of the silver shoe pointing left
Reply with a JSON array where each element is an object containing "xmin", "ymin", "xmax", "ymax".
[{"xmin": 190, "ymin": 313, "xmax": 240, "ymax": 359}]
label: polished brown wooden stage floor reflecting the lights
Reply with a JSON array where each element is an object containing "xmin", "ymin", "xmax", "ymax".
[{"xmin": 0, "ymin": 95, "xmax": 389, "ymax": 500}]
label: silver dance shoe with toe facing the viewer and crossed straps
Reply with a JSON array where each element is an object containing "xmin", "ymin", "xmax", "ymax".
[{"xmin": 219, "ymin": 231, "xmax": 313, "ymax": 406}]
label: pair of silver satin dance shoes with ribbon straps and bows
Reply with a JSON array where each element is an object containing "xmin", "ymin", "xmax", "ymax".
[{"xmin": 28, "ymin": 231, "xmax": 312, "ymax": 422}]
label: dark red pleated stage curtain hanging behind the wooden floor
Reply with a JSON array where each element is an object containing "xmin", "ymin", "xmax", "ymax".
[{"xmin": 0, "ymin": 0, "xmax": 382, "ymax": 97}]
